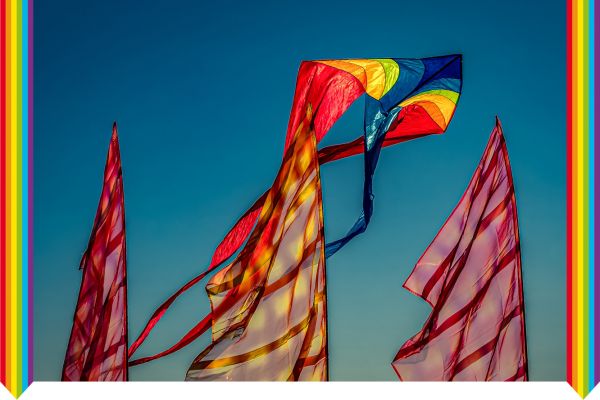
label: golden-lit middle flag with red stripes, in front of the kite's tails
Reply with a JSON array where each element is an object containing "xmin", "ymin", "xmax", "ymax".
[{"xmin": 186, "ymin": 107, "xmax": 327, "ymax": 380}]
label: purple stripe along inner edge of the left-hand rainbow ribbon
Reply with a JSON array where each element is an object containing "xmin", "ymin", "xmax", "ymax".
[{"xmin": 28, "ymin": 0, "xmax": 33, "ymax": 385}]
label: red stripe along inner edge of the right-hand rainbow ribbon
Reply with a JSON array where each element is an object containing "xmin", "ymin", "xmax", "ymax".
[{"xmin": 566, "ymin": 0, "xmax": 573, "ymax": 386}]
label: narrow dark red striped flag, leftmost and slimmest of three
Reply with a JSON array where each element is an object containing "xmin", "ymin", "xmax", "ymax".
[{"xmin": 62, "ymin": 124, "xmax": 127, "ymax": 381}]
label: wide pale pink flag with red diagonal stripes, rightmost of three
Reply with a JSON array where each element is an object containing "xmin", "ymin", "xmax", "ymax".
[{"xmin": 392, "ymin": 120, "xmax": 527, "ymax": 381}]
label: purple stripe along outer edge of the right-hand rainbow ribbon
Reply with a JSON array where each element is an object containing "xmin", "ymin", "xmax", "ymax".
[{"xmin": 590, "ymin": 0, "xmax": 600, "ymax": 385}]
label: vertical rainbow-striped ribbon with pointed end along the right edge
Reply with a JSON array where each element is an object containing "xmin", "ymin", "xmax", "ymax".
[{"xmin": 567, "ymin": 0, "xmax": 600, "ymax": 397}]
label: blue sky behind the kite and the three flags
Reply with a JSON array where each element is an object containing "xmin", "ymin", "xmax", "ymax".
[{"xmin": 34, "ymin": 0, "xmax": 566, "ymax": 381}]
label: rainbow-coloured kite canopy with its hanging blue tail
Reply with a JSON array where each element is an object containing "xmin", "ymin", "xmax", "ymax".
[{"xmin": 298, "ymin": 55, "xmax": 462, "ymax": 257}]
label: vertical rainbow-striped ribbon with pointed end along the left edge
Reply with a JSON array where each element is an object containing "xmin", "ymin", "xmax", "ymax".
[{"xmin": 0, "ymin": 0, "xmax": 33, "ymax": 396}]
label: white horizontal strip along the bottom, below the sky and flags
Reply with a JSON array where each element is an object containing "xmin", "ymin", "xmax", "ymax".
[{"xmin": 0, "ymin": 382, "xmax": 600, "ymax": 400}]
